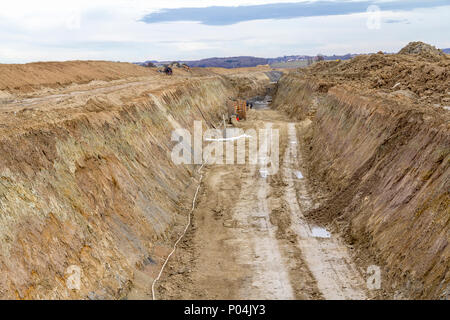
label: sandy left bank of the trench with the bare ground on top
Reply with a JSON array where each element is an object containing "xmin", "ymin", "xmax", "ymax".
[{"xmin": 0, "ymin": 62, "xmax": 269, "ymax": 299}]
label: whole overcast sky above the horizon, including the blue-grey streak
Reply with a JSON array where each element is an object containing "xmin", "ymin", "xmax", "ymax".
[{"xmin": 0, "ymin": 0, "xmax": 450, "ymax": 63}]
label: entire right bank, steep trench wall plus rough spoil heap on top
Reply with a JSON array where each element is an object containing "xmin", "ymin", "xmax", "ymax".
[{"xmin": 274, "ymin": 43, "xmax": 450, "ymax": 299}]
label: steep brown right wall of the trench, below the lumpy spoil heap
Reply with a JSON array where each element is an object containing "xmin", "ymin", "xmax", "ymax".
[{"xmin": 274, "ymin": 73, "xmax": 450, "ymax": 299}]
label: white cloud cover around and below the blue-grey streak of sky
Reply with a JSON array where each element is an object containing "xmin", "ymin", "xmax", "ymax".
[{"xmin": 0, "ymin": 0, "xmax": 450, "ymax": 63}]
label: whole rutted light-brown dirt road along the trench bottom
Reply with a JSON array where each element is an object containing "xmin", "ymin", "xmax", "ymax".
[{"xmin": 149, "ymin": 100, "xmax": 371, "ymax": 299}]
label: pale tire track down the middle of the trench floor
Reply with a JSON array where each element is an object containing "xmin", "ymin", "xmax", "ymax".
[{"xmin": 233, "ymin": 123, "xmax": 294, "ymax": 300}]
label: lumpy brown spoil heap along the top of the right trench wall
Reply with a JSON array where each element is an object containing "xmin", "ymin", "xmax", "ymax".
[{"xmin": 299, "ymin": 46, "xmax": 450, "ymax": 107}]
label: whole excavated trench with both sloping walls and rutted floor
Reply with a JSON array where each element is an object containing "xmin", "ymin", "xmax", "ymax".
[{"xmin": 0, "ymin": 63, "xmax": 450, "ymax": 299}]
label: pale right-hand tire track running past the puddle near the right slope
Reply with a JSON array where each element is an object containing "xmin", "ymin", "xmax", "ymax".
[{"xmin": 283, "ymin": 123, "xmax": 367, "ymax": 300}]
